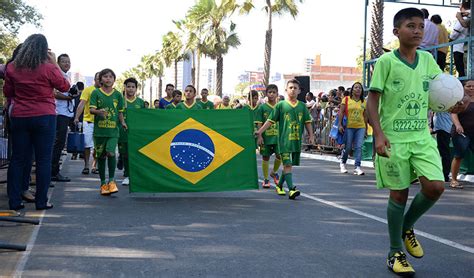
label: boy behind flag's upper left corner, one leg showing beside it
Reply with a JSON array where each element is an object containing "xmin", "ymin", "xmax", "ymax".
[{"xmin": 118, "ymin": 77, "xmax": 145, "ymax": 185}]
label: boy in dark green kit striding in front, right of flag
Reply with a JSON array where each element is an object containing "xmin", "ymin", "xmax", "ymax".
[{"xmin": 255, "ymin": 79, "xmax": 314, "ymax": 200}]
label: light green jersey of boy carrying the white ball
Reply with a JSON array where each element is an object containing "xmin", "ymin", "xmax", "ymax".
[{"xmin": 370, "ymin": 49, "xmax": 441, "ymax": 143}]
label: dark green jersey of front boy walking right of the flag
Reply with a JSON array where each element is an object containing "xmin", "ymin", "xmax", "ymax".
[{"xmin": 268, "ymin": 100, "xmax": 312, "ymax": 153}]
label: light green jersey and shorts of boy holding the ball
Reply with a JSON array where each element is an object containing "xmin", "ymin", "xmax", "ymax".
[{"xmin": 370, "ymin": 49, "xmax": 444, "ymax": 190}]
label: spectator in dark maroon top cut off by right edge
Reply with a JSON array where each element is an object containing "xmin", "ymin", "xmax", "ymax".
[{"xmin": 449, "ymin": 80, "xmax": 474, "ymax": 189}]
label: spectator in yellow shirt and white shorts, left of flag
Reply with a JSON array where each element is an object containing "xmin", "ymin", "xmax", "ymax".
[{"xmin": 74, "ymin": 72, "xmax": 100, "ymax": 175}]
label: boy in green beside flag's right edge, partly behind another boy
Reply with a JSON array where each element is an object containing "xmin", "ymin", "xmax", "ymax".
[{"xmin": 255, "ymin": 84, "xmax": 285, "ymax": 191}]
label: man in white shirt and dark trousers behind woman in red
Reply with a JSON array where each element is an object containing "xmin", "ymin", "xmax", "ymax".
[{"xmin": 51, "ymin": 54, "xmax": 74, "ymax": 182}]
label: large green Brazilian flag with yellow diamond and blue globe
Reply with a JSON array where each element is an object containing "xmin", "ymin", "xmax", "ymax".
[{"xmin": 127, "ymin": 109, "xmax": 258, "ymax": 193}]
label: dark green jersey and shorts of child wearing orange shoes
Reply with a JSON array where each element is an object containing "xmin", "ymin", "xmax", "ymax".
[{"xmin": 90, "ymin": 88, "xmax": 124, "ymax": 157}]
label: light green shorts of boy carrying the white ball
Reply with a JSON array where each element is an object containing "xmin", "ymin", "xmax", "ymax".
[{"xmin": 375, "ymin": 138, "xmax": 444, "ymax": 190}]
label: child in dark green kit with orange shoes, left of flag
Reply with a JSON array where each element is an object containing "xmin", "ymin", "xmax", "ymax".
[{"xmin": 89, "ymin": 69, "xmax": 127, "ymax": 195}]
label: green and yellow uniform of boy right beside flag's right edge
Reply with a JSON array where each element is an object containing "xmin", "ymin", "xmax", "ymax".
[{"xmin": 255, "ymin": 103, "xmax": 280, "ymax": 156}]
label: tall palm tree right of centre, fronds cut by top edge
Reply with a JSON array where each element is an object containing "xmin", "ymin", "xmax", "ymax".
[{"xmin": 263, "ymin": 0, "xmax": 303, "ymax": 86}]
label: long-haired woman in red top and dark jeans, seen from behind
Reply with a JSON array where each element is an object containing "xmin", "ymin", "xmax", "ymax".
[{"xmin": 3, "ymin": 34, "xmax": 70, "ymax": 210}]
